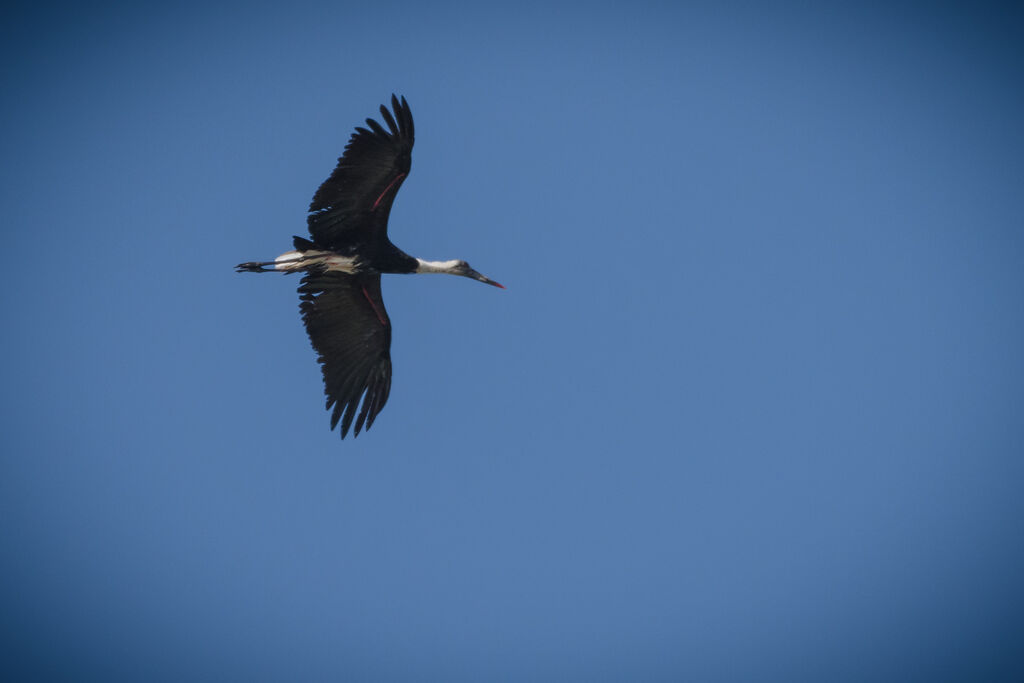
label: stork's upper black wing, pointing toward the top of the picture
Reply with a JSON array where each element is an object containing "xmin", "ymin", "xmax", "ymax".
[{"xmin": 306, "ymin": 95, "xmax": 415, "ymax": 249}]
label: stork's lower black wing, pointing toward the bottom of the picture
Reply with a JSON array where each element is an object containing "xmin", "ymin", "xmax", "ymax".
[{"xmin": 299, "ymin": 272, "xmax": 391, "ymax": 438}]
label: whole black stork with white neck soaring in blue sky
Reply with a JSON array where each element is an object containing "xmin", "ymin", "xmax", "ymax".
[{"xmin": 236, "ymin": 95, "xmax": 505, "ymax": 438}]
